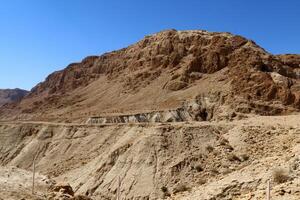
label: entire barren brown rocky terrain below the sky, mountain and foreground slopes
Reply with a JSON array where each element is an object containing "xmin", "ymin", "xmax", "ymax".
[{"xmin": 0, "ymin": 30, "xmax": 300, "ymax": 200}]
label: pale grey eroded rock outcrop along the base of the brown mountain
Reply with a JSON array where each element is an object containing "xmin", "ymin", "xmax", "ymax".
[{"xmin": 86, "ymin": 94, "xmax": 234, "ymax": 124}]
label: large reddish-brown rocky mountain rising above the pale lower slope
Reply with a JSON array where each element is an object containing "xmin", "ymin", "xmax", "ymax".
[{"xmin": 1, "ymin": 30, "xmax": 300, "ymax": 120}]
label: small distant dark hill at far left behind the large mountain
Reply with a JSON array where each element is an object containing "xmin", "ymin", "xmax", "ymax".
[{"xmin": 0, "ymin": 88, "xmax": 29, "ymax": 107}]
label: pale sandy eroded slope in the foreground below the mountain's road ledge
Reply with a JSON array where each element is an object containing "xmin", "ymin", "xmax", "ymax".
[{"xmin": 0, "ymin": 114, "xmax": 300, "ymax": 200}]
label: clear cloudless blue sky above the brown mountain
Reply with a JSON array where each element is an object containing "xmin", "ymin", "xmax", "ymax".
[{"xmin": 0, "ymin": 0, "xmax": 300, "ymax": 89}]
